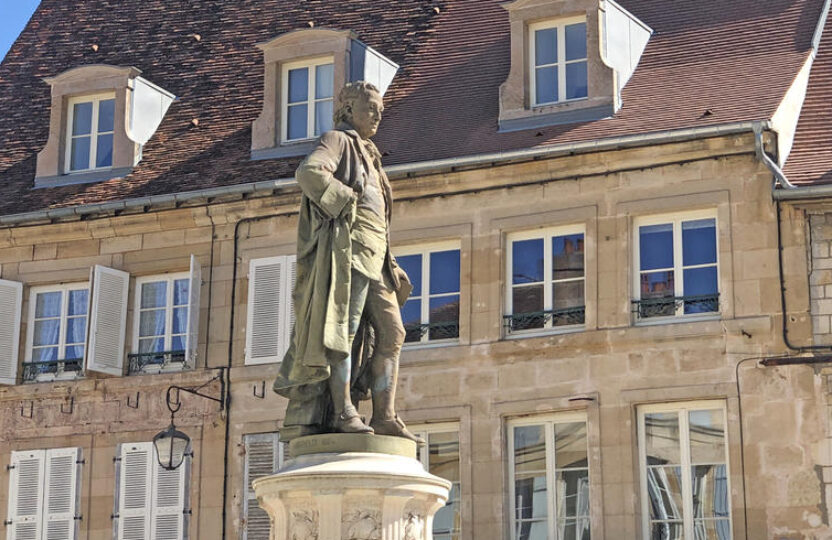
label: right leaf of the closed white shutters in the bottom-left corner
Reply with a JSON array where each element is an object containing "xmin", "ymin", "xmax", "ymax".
[{"xmin": 42, "ymin": 448, "xmax": 81, "ymax": 540}]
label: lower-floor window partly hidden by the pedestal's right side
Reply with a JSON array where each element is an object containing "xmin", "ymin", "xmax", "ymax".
[{"xmin": 412, "ymin": 423, "xmax": 462, "ymax": 540}]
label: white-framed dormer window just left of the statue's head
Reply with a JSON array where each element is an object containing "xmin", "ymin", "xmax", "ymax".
[{"xmin": 281, "ymin": 57, "xmax": 335, "ymax": 142}]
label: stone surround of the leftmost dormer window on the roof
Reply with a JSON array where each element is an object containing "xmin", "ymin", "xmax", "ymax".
[{"xmin": 35, "ymin": 64, "xmax": 141, "ymax": 188}]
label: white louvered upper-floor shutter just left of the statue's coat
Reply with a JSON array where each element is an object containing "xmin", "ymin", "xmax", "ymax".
[{"xmin": 246, "ymin": 257, "xmax": 286, "ymax": 365}]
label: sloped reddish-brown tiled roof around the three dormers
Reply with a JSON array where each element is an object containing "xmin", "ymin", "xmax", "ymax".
[{"xmin": 0, "ymin": 0, "xmax": 832, "ymax": 215}]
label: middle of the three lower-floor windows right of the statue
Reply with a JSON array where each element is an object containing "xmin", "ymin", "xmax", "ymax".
[{"xmin": 508, "ymin": 413, "xmax": 590, "ymax": 540}]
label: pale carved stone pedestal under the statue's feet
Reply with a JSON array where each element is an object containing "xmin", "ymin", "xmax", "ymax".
[{"xmin": 254, "ymin": 434, "xmax": 451, "ymax": 540}]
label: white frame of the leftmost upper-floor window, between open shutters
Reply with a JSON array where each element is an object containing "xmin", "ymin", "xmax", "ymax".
[{"xmin": 24, "ymin": 281, "xmax": 91, "ymax": 382}]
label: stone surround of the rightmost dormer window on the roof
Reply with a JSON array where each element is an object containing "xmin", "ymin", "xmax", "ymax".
[{"xmin": 499, "ymin": 0, "xmax": 615, "ymax": 131}]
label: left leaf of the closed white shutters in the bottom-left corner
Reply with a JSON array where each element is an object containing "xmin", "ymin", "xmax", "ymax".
[{"xmin": 6, "ymin": 450, "xmax": 46, "ymax": 540}]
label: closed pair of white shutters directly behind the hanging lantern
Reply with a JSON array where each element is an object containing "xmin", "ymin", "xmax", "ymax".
[{"xmin": 113, "ymin": 442, "xmax": 191, "ymax": 540}]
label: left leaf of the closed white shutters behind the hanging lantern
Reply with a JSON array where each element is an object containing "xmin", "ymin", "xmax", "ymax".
[{"xmin": 116, "ymin": 442, "xmax": 154, "ymax": 540}]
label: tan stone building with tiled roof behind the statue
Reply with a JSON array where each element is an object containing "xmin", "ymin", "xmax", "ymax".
[{"xmin": 0, "ymin": 0, "xmax": 832, "ymax": 540}]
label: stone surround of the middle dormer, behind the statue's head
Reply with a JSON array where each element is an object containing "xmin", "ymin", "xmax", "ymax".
[{"xmin": 251, "ymin": 28, "xmax": 356, "ymax": 159}]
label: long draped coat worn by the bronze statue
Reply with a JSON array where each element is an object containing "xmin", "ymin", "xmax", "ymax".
[{"xmin": 274, "ymin": 125, "xmax": 411, "ymax": 400}]
